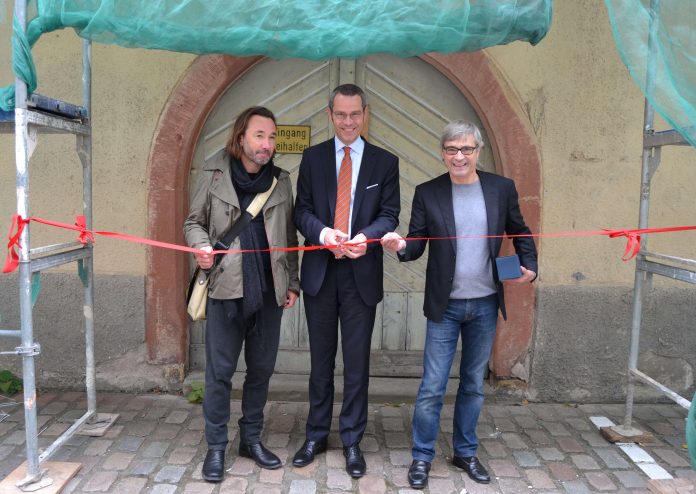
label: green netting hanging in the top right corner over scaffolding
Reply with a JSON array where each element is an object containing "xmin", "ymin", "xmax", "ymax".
[{"xmin": 605, "ymin": 0, "xmax": 696, "ymax": 146}]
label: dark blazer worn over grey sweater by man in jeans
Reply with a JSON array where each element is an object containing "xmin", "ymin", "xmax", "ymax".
[{"xmin": 399, "ymin": 171, "xmax": 538, "ymax": 321}]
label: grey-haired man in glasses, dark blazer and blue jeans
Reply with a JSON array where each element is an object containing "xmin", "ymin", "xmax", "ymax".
[{"xmin": 382, "ymin": 121, "xmax": 537, "ymax": 489}]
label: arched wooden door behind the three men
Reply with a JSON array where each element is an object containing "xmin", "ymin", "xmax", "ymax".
[{"xmin": 189, "ymin": 55, "xmax": 495, "ymax": 375}]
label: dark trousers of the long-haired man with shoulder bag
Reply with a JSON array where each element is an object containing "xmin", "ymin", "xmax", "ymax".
[{"xmin": 203, "ymin": 280, "xmax": 283, "ymax": 450}]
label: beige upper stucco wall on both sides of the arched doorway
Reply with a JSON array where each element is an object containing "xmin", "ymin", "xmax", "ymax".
[{"xmin": 0, "ymin": 0, "xmax": 696, "ymax": 285}]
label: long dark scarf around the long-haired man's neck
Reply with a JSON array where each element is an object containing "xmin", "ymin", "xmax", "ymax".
[{"xmin": 230, "ymin": 158, "xmax": 280, "ymax": 322}]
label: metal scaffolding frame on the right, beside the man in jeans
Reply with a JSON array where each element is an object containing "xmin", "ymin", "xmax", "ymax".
[{"xmin": 607, "ymin": 0, "xmax": 696, "ymax": 442}]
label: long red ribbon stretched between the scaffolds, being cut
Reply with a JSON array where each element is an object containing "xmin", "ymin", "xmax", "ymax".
[{"xmin": 2, "ymin": 214, "xmax": 696, "ymax": 273}]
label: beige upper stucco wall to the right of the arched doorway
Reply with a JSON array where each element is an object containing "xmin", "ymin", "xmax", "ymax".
[{"xmin": 488, "ymin": 1, "xmax": 696, "ymax": 285}]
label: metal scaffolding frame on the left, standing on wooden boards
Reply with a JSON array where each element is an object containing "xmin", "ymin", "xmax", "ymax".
[{"xmin": 0, "ymin": 0, "xmax": 118, "ymax": 492}]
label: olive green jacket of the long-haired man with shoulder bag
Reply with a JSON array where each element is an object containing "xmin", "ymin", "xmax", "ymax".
[{"xmin": 184, "ymin": 150, "xmax": 300, "ymax": 306}]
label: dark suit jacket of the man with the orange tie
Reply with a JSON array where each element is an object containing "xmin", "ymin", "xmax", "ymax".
[{"xmin": 295, "ymin": 138, "xmax": 401, "ymax": 305}]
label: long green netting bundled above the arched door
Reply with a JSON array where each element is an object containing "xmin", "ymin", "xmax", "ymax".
[{"xmin": 0, "ymin": 0, "xmax": 552, "ymax": 110}]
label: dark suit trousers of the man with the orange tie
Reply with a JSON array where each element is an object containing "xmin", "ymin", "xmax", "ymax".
[{"xmin": 304, "ymin": 258, "xmax": 376, "ymax": 446}]
